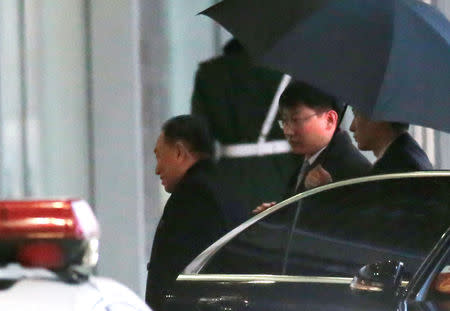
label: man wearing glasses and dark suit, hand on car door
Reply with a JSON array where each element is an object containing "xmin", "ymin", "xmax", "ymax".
[{"xmin": 253, "ymin": 82, "xmax": 371, "ymax": 213}]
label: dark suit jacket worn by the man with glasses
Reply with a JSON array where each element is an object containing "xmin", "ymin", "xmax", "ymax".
[{"xmin": 287, "ymin": 129, "xmax": 372, "ymax": 196}]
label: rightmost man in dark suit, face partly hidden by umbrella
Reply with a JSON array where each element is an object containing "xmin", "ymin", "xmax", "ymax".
[{"xmin": 350, "ymin": 110, "xmax": 433, "ymax": 175}]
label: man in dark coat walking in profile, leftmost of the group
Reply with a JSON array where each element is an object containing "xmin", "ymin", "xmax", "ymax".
[{"xmin": 146, "ymin": 115, "xmax": 226, "ymax": 311}]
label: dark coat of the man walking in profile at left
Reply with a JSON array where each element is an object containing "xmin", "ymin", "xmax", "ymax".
[{"xmin": 145, "ymin": 160, "xmax": 225, "ymax": 311}]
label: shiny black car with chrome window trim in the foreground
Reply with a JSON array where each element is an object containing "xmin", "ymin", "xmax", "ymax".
[{"xmin": 164, "ymin": 171, "xmax": 450, "ymax": 310}]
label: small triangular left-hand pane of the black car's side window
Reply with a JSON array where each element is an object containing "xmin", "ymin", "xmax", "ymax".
[{"xmin": 200, "ymin": 207, "xmax": 294, "ymax": 274}]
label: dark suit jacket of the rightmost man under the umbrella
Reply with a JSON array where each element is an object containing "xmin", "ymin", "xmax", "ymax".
[{"xmin": 371, "ymin": 133, "xmax": 433, "ymax": 175}]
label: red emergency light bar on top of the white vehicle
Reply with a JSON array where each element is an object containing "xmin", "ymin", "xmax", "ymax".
[{"xmin": 0, "ymin": 200, "xmax": 100, "ymax": 270}]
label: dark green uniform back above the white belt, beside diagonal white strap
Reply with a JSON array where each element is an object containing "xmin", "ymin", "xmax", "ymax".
[{"xmin": 192, "ymin": 52, "xmax": 284, "ymax": 145}]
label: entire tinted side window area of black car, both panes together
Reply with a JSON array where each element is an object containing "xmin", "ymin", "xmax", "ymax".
[{"xmin": 200, "ymin": 176, "xmax": 450, "ymax": 276}]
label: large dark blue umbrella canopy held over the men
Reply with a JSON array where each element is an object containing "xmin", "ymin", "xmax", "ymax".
[{"xmin": 201, "ymin": 0, "xmax": 450, "ymax": 132}]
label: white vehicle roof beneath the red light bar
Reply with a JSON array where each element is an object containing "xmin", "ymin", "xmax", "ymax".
[{"xmin": 0, "ymin": 264, "xmax": 150, "ymax": 311}]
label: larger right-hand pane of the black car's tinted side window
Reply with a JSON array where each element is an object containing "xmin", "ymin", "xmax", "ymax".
[{"xmin": 285, "ymin": 177, "xmax": 450, "ymax": 276}]
